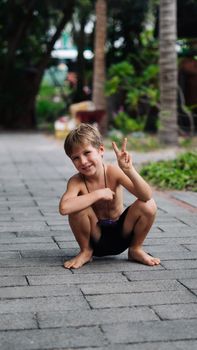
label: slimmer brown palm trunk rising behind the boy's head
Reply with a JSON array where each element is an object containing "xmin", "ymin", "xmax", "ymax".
[{"xmin": 93, "ymin": 0, "xmax": 107, "ymax": 134}]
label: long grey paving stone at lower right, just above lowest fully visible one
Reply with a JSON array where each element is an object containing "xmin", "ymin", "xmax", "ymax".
[{"xmin": 86, "ymin": 291, "xmax": 196, "ymax": 309}]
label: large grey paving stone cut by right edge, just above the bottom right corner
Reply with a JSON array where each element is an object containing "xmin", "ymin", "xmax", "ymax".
[{"xmin": 102, "ymin": 320, "xmax": 197, "ymax": 344}]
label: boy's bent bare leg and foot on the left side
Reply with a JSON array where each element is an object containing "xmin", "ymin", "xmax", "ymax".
[{"xmin": 64, "ymin": 208, "xmax": 99, "ymax": 269}]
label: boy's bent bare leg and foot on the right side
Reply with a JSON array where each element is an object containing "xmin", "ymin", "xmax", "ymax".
[{"xmin": 124, "ymin": 199, "xmax": 160, "ymax": 266}]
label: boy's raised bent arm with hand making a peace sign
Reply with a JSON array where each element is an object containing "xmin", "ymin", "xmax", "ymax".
[{"xmin": 112, "ymin": 138, "xmax": 152, "ymax": 202}]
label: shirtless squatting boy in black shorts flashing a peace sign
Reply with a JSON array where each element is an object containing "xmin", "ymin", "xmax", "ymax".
[{"xmin": 59, "ymin": 123, "xmax": 160, "ymax": 269}]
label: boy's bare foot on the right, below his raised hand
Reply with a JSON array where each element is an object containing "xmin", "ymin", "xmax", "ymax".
[{"xmin": 128, "ymin": 248, "xmax": 160, "ymax": 266}]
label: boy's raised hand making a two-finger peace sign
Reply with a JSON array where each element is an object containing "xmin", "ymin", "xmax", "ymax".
[{"xmin": 112, "ymin": 138, "xmax": 132, "ymax": 171}]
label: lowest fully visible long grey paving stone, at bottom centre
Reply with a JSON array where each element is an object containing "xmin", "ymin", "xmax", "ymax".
[{"xmin": 38, "ymin": 307, "xmax": 159, "ymax": 328}]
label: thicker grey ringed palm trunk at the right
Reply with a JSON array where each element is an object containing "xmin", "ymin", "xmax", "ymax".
[{"xmin": 159, "ymin": 0, "xmax": 178, "ymax": 145}]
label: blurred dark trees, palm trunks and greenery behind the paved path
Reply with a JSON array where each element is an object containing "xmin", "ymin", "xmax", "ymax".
[{"xmin": 0, "ymin": 0, "xmax": 197, "ymax": 148}]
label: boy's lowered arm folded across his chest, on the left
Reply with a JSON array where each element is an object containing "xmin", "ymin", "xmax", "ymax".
[{"xmin": 59, "ymin": 178, "xmax": 114, "ymax": 215}]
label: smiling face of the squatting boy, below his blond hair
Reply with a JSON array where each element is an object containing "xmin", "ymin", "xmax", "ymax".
[{"xmin": 70, "ymin": 143, "xmax": 104, "ymax": 176}]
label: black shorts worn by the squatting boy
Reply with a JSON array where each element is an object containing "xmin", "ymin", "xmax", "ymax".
[{"xmin": 90, "ymin": 207, "xmax": 133, "ymax": 257}]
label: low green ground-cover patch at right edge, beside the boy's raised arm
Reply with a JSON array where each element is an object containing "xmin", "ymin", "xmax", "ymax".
[{"xmin": 141, "ymin": 152, "xmax": 197, "ymax": 192}]
